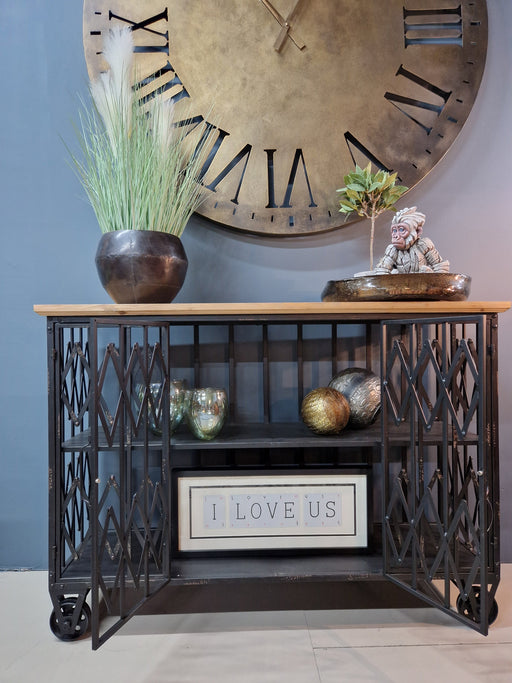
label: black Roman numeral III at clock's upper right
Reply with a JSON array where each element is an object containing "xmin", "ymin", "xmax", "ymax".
[{"xmin": 403, "ymin": 5, "xmax": 463, "ymax": 48}]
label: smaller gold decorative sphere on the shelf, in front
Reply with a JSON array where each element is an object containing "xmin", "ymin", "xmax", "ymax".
[{"xmin": 301, "ymin": 387, "xmax": 350, "ymax": 434}]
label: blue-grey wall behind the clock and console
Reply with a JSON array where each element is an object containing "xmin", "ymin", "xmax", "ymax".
[{"xmin": 0, "ymin": 0, "xmax": 512, "ymax": 569}]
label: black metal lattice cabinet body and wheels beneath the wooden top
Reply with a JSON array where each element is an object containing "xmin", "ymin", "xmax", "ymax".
[{"xmin": 44, "ymin": 313, "xmax": 499, "ymax": 648}]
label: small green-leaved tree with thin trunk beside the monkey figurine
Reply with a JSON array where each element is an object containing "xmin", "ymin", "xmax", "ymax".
[{"xmin": 337, "ymin": 163, "xmax": 409, "ymax": 270}]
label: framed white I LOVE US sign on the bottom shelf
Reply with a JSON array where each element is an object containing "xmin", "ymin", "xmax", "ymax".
[{"xmin": 178, "ymin": 473, "xmax": 368, "ymax": 551}]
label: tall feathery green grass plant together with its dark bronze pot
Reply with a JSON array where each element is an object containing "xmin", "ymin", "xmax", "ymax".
[{"xmin": 70, "ymin": 28, "xmax": 212, "ymax": 303}]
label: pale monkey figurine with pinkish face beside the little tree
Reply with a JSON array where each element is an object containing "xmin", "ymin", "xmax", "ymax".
[{"xmin": 368, "ymin": 206, "xmax": 450, "ymax": 275}]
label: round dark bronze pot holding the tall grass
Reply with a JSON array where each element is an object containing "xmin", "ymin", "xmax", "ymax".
[{"xmin": 96, "ymin": 230, "xmax": 188, "ymax": 304}]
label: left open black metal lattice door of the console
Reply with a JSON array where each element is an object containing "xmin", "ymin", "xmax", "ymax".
[{"xmin": 91, "ymin": 323, "xmax": 170, "ymax": 647}]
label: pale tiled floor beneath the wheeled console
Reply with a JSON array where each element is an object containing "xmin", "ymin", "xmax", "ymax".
[{"xmin": 0, "ymin": 564, "xmax": 512, "ymax": 683}]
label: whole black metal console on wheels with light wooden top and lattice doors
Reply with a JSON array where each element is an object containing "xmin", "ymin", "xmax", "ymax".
[{"xmin": 35, "ymin": 302, "xmax": 510, "ymax": 648}]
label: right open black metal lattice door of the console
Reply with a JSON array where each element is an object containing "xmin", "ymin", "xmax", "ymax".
[{"xmin": 381, "ymin": 316, "xmax": 499, "ymax": 634}]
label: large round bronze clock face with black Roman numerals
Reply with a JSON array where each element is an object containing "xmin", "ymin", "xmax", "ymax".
[{"xmin": 84, "ymin": 0, "xmax": 487, "ymax": 236}]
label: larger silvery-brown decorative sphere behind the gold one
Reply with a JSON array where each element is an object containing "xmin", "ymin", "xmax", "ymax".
[{"xmin": 329, "ymin": 368, "xmax": 381, "ymax": 427}]
